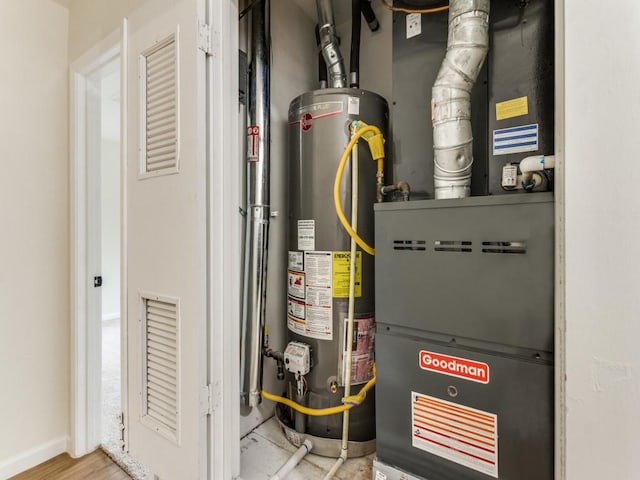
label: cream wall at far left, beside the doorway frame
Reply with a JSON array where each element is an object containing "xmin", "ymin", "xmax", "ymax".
[{"xmin": 0, "ymin": 0, "xmax": 69, "ymax": 472}]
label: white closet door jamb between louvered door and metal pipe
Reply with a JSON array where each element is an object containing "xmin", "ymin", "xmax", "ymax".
[{"xmin": 206, "ymin": 0, "xmax": 242, "ymax": 480}]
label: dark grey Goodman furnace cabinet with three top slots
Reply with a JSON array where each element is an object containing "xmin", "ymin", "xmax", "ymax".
[{"xmin": 375, "ymin": 193, "xmax": 554, "ymax": 480}]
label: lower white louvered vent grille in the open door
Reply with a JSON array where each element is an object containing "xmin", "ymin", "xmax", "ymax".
[{"xmin": 141, "ymin": 295, "xmax": 180, "ymax": 443}]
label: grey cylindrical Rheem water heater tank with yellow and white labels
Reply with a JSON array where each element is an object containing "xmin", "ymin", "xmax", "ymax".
[{"xmin": 279, "ymin": 89, "xmax": 388, "ymax": 450}]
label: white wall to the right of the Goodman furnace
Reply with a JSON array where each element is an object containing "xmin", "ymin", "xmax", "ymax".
[{"xmin": 564, "ymin": 0, "xmax": 640, "ymax": 480}]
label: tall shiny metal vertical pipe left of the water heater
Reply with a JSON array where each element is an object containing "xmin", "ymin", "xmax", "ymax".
[{"xmin": 240, "ymin": 0, "xmax": 270, "ymax": 407}]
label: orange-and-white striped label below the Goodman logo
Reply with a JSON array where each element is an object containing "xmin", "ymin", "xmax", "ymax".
[{"xmin": 411, "ymin": 392, "xmax": 498, "ymax": 478}]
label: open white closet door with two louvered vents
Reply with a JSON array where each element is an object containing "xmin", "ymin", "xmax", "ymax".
[{"xmin": 126, "ymin": 0, "xmax": 207, "ymax": 480}]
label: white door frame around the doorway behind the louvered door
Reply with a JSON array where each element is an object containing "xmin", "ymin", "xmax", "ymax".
[{"xmin": 69, "ymin": 28, "xmax": 127, "ymax": 457}]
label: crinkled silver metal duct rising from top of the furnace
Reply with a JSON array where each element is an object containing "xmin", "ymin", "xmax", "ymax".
[{"xmin": 431, "ymin": 0, "xmax": 489, "ymax": 198}]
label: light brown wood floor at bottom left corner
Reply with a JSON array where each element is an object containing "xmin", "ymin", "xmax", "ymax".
[{"xmin": 9, "ymin": 450, "xmax": 131, "ymax": 480}]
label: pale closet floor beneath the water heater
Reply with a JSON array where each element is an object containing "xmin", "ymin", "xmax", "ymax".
[{"xmin": 240, "ymin": 418, "xmax": 374, "ymax": 480}]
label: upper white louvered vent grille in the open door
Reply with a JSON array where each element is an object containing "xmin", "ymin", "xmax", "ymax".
[{"xmin": 140, "ymin": 34, "xmax": 179, "ymax": 177}]
